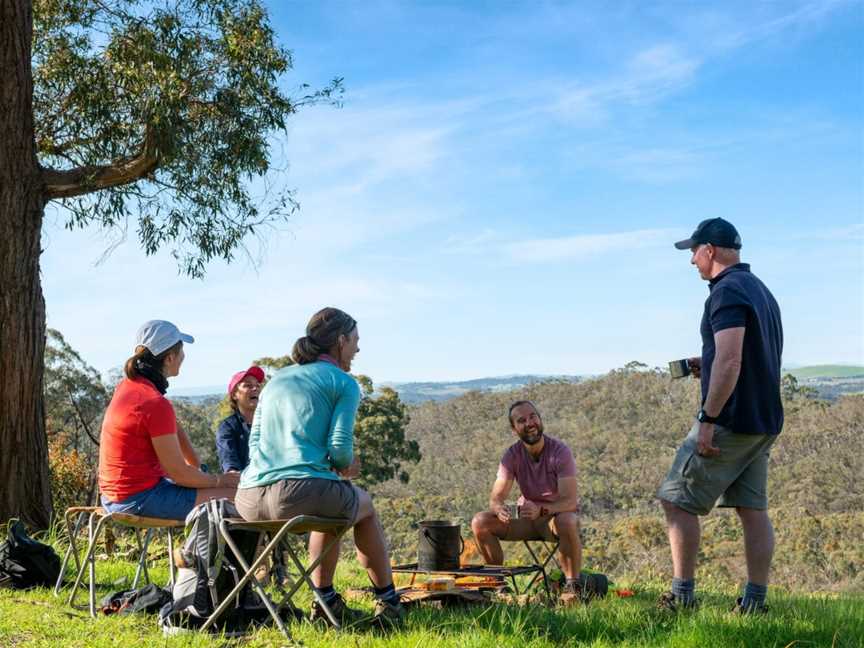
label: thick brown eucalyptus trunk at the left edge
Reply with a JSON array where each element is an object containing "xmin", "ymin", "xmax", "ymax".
[{"xmin": 0, "ymin": 0, "xmax": 51, "ymax": 528}]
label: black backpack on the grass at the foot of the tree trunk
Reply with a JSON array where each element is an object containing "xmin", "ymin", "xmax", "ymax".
[{"xmin": 0, "ymin": 519, "xmax": 60, "ymax": 589}]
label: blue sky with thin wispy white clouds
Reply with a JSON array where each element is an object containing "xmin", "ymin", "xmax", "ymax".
[{"xmin": 42, "ymin": 1, "xmax": 864, "ymax": 389}]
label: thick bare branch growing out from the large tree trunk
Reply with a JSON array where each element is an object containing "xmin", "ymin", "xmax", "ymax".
[{"xmin": 42, "ymin": 127, "xmax": 159, "ymax": 200}]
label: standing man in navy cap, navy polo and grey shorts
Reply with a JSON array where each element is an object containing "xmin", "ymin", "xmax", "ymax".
[{"xmin": 657, "ymin": 218, "xmax": 783, "ymax": 613}]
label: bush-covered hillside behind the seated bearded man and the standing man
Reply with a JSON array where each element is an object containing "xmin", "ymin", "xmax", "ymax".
[{"xmin": 373, "ymin": 370, "xmax": 864, "ymax": 592}]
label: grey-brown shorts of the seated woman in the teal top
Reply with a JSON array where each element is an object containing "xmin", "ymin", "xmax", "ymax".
[{"xmin": 234, "ymin": 478, "xmax": 360, "ymax": 524}]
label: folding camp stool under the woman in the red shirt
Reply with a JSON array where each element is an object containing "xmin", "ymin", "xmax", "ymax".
[{"xmin": 68, "ymin": 508, "xmax": 186, "ymax": 618}]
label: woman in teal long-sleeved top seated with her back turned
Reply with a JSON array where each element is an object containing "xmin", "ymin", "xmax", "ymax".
[{"xmin": 236, "ymin": 308, "xmax": 404, "ymax": 625}]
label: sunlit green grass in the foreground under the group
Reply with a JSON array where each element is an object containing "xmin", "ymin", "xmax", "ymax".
[{"xmin": 0, "ymin": 560, "xmax": 864, "ymax": 648}]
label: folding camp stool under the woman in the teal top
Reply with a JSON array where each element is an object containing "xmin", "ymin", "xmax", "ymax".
[{"xmin": 201, "ymin": 515, "xmax": 351, "ymax": 640}]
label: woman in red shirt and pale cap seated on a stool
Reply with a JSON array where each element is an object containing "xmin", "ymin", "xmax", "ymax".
[{"xmin": 99, "ymin": 320, "xmax": 240, "ymax": 520}]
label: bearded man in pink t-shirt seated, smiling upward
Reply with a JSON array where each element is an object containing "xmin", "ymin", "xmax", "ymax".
[{"xmin": 471, "ymin": 400, "xmax": 590, "ymax": 602}]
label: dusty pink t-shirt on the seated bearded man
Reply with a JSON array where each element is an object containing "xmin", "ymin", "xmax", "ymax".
[{"xmin": 498, "ymin": 436, "xmax": 576, "ymax": 502}]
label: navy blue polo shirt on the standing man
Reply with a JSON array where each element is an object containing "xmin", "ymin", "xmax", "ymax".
[{"xmin": 701, "ymin": 263, "xmax": 783, "ymax": 434}]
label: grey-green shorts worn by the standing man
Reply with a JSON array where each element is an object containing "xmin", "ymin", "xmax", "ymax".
[{"xmin": 657, "ymin": 423, "xmax": 777, "ymax": 515}]
